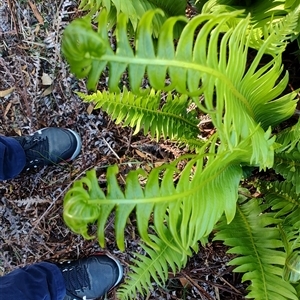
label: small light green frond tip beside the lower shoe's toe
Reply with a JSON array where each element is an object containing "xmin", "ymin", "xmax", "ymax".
[{"xmin": 117, "ymin": 235, "xmax": 187, "ymax": 300}]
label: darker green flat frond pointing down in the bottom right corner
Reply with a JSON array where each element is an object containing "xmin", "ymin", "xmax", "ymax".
[{"xmin": 215, "ymin": 199, "xmax": 298, "ymax": 300}]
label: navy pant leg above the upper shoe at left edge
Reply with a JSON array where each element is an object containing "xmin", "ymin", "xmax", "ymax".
[{"xmin": 0, "ymin": 136, "xmax": 26, "ymax": 180}]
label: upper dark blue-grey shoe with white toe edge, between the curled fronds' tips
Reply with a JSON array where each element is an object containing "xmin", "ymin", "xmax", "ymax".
[{"xmin": 14, "ymin": 127, "xmax": 81, "ymax": 170}]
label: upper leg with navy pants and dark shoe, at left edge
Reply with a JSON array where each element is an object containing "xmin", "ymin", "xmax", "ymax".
[{"xmin": 0, "ymin": 127, "xmax": 81, "ymax": 181}]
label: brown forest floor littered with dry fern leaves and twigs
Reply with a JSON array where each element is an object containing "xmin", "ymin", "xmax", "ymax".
[{"xmin": 0, "ymin": 0, "xmax": 300, "ymax": 300}]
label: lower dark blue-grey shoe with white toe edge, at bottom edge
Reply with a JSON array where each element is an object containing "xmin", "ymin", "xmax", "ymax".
[{"xmin": 58, "ymin": 254, "xmax": 123, "ymax": 300}]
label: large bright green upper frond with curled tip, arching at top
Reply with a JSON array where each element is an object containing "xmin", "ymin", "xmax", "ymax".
[{"xmin": 62, "ymin": 10, "xmax": 296, "ymax": 168}]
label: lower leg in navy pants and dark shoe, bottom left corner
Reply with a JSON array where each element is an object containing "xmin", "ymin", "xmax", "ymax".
[{"xmin": 0, "ymin": 254, "xmax": 123, "ymax": 300}]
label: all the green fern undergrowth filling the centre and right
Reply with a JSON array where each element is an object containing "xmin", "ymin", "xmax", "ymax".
[{"xmin": 62, "ymin": 0, "xmax": 300, "ymax": 300}]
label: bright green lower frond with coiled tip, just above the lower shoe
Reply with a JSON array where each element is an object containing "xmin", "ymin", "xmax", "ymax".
[{"xmin": 64, "ymin": 141, "xmax": 244, "ymax": 254}]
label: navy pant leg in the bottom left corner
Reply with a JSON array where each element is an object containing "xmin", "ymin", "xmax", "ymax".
[{"xmin": 0, "ymin": 262, "xmax": 66, "ymax": 300}]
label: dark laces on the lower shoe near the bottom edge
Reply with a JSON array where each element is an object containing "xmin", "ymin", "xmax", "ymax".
[{"xmin": 61, "ymin": 265, "xmax": 91, "ymax": 294}]
